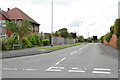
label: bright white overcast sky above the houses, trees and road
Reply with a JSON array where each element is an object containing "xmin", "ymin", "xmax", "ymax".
[{"xmin": 0, "ymin": 0, "xmax": 119, "ymax": 38}]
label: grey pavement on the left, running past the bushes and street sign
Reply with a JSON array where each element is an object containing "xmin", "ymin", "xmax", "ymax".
[{"xmin": 0, "ymin": 46, "xmax": 52, "ymax": 58}]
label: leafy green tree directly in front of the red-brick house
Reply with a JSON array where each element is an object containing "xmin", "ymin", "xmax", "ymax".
[{"xmin": 5, "ymin": 19, "xmax": 31, "ymax": 38}]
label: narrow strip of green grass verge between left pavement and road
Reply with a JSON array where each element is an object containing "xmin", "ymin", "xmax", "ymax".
[{"xmin": 41, "ymin": 43, "xmax": 86, "ymax": 50}]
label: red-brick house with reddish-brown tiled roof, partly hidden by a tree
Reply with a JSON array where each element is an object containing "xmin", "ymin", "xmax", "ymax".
[{"xmin": 0, "ymin": 8, "xmax": 40, "ymax": 37}]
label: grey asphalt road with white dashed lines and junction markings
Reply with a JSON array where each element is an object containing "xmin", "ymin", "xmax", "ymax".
[{"xmin": 2, "ymin": 43, "xmax": 118, "ymax": 78}]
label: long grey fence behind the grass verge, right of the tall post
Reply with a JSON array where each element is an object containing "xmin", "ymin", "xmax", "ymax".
[{"xmin": 53, "ymin": 37, "xmax": 76, "ymax": 45}]
